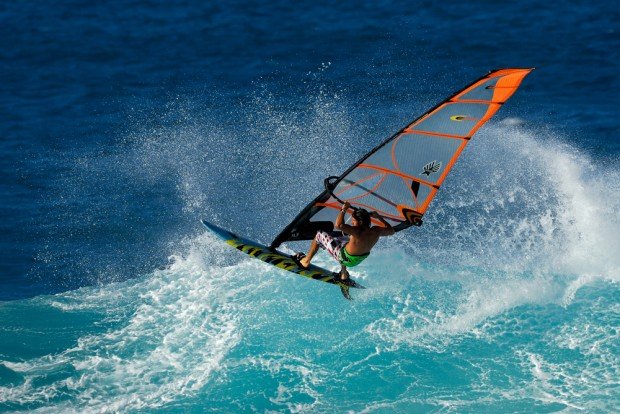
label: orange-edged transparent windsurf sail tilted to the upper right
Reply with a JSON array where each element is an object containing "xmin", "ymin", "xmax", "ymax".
[{"xmin": 270, "ymin": 68, "xmax": 532, "ymax": 248}]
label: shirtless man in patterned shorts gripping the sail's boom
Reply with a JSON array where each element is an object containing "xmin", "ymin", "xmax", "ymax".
[{"xmin": 295, "ymin": 202, "xmax": 394, "ymax": 281}]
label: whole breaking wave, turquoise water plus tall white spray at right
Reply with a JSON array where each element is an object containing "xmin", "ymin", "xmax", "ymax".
[{"xmin": 0, "ymin": 114, "xmax": 620, "ymax": 412}]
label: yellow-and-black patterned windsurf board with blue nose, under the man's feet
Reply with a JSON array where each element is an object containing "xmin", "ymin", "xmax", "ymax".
[{"xmin": 202, "ymin": 220, "xmax": 365, "ymax": 300}]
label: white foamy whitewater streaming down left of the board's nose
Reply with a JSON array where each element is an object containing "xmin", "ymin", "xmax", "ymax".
[{"xmin": 0, "ymin": 236, "xmax": 244, "ymax": 412}]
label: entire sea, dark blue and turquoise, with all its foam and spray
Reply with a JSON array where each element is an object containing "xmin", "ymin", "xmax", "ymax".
[{"xmin": 0, "ymin": 1, "xmax": 620, "ymax": 412}]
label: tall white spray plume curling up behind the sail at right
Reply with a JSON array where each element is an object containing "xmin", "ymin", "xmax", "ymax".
[{"xmin": 366, "ymin": 123, "xmax": 620, "ymax": 349}]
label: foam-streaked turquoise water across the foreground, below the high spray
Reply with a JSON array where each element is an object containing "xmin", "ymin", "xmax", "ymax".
[{"xmin": 0, "ymin": 252, "xmax": 620, "ymax": 412}]
